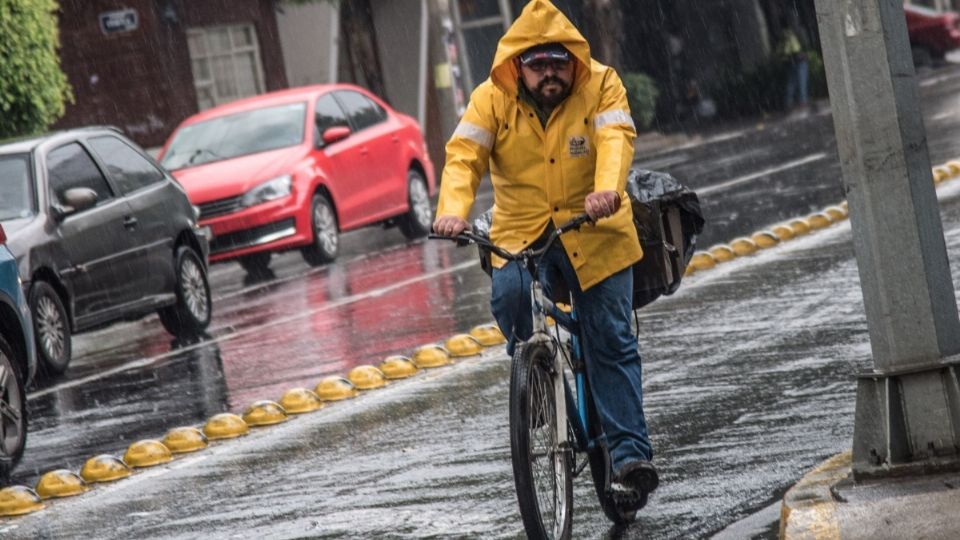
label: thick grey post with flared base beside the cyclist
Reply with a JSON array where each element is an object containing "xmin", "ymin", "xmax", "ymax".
[{"xmin": 816, "ymin": 0, "xmax": 960, "ymax": 476}]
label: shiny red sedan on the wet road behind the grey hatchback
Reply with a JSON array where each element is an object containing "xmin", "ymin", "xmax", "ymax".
[{"xmin": 159, "ymin": 84, "xmax": 436, "ymax": 274}]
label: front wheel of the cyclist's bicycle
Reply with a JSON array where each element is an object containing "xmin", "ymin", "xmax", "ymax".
[{"xmin": 510, "ymin": 344, "xmax": 573, "ymax": 540}]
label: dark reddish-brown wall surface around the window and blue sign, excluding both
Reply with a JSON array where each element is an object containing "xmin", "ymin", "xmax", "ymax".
[{"xmin": 54, "ymin": 0, "xmax": 287, "ymax": 147}]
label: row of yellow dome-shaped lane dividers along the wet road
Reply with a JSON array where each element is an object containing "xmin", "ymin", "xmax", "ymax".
[{"xmin": 0, "ymin": 161, "xmax": 960, "ymax": 516}]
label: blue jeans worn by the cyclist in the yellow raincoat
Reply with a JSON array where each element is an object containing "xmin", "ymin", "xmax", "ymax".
[{"xmin": 490, "ymin": 242, "xmax": 653, "ymax": 472}]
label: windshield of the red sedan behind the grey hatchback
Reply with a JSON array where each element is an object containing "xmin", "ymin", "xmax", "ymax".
[{"xmin": 162, "ymin": 103, "xmax": 307, "ymax": 171}]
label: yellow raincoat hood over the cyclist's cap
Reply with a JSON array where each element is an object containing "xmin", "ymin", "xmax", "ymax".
[{"xmin": 490, "ymin": 0, "xmax": 590, "ymax": 95}]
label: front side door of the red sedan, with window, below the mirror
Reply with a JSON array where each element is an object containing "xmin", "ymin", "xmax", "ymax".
[{"xmin": 314, "ymin": 94, "xmax": 367, "ymax": 229}]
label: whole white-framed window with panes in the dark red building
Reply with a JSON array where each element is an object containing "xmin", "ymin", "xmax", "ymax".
[{"xmin": 187, "ymin": 24, "xmax": 264, "ymax": 111}]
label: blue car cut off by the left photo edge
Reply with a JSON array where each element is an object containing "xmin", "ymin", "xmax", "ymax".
[{"xmin": 0, "ymin": 226, "xmax": 37, "ymax": 484}]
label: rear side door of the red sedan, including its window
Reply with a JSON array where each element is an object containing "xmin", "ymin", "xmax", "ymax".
[{"xmin": 335, "ymin": 90, "xmax": 407, "ymax": 221}]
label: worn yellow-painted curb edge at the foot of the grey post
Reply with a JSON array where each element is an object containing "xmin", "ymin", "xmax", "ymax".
[{"xmin": 780, "ymin": 450, "xmax": 853, "ymax": 540}]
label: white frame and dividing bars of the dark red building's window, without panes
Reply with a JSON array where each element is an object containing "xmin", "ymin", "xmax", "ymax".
[{"xmin": 187, "ymin": 23, "xmax": 264, "ymax": 110}]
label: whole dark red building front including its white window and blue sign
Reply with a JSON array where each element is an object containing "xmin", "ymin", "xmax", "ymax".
[{"xmin": 54, "ymin": 0, "xmax": 287, "ymax": 147}]
